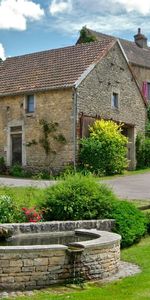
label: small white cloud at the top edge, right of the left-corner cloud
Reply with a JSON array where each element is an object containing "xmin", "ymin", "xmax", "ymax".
[{"xmin": 49, "ymin": 0, "xmax": 72, "ymax": 16}]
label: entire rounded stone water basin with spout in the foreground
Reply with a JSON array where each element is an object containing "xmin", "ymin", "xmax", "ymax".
[{"xmin": 0, "ymin": 221, "xmax": 121, "ymax": 291}]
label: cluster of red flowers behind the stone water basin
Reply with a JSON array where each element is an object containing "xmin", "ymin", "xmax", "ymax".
[{"xmin": 22, "ymin": 207, "xmax": 42, "ymax": 223}]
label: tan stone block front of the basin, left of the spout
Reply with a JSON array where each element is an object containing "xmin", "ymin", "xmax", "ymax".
[{"xmin": 0, "ymin": 246, "xmax": 69, "ymax": 290}]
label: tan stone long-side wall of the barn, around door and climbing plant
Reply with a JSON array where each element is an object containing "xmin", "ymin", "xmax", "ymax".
[{"xmin": 0, "ymin": 89, "xmax": 73, "ymax": 169}]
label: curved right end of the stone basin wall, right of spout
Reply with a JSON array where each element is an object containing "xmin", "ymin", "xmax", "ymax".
[{"xmin": 69, "ymin": 230, "xmax": 121, "ymax": 280}]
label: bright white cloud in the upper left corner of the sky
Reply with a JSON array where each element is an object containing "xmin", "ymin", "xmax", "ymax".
[{"xmin": 0, "ymin": 0, "xmax": 44, "ymax": 30}]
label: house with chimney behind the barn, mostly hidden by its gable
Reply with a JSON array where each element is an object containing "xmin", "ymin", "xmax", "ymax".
[{"xmin": 77, "ymin": 27, "xmax": 150, "ymax": 101}]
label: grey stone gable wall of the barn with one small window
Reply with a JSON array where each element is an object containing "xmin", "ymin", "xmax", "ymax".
[{"xmin": 77, "ymin": 44, "xmax": 146, "ymax": 132}]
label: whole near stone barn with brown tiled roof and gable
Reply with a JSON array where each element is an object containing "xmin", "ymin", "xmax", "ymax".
[{"xmin": 0, "ymin": 39, "xmax": 146, "ymax": 170}]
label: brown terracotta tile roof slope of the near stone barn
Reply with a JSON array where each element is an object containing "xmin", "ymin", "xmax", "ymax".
[{"xmin": 0, "ymin": 39, "xmax": 114, "ymax": 96}]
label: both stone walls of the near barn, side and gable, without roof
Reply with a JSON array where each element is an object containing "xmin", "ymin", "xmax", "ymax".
[{"xmin": 0, "ymin": 44, "xmax": 146, "ymax": 171}]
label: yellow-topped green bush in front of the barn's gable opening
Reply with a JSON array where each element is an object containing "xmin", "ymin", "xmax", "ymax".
[{"xmin": 80, "ymin": 120, "xmax": 128, "ymax": 175}]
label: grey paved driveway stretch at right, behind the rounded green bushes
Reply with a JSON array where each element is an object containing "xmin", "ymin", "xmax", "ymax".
[{"xmin": 101, "ymin": 173, "xmax": 150, "ymax": 200}]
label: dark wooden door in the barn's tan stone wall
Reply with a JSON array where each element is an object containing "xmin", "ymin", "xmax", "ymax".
[{"xmin": 11, "ymin": 133, "xmax": 22, "ymax": 165}]
